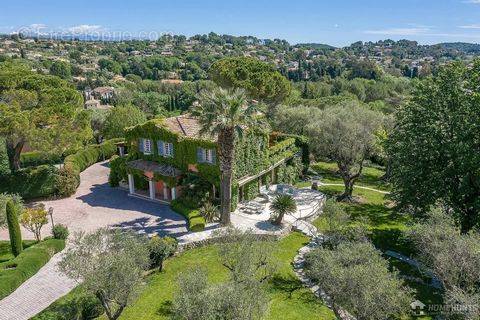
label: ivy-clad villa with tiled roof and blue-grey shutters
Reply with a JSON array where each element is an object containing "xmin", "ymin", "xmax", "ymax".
[{"xmin": 111, "ymin": 115, "xmax": 308, "ymax": 206}]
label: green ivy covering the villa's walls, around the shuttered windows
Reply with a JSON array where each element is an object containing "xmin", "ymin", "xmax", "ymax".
[{"xmin": 112, "ymin": 119, "xmax": 309, "ymax": 209}]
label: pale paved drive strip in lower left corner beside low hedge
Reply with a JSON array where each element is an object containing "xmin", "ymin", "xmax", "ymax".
[{"xmin": 0, "ymin": 253, "xmax": 77, "ymax": 320}]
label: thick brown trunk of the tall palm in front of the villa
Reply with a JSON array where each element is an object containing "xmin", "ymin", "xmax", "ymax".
[{"xmin": 218, "ymin": 128, "xmax": 235, "ymax": 226}]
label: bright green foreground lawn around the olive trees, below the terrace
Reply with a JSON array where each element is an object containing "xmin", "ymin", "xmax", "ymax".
[{"xmin": 34, "ymin": 233, "xmax": 335, "ymax": 320}]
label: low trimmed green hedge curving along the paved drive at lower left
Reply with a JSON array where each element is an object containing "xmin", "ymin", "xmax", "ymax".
[{"xmin": 0, "ymin": 239, "xmax": 65, "ymax": 300}]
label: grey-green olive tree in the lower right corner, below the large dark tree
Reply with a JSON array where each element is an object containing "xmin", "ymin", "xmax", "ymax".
[{"xmin": 410, "ymin": 209, "xmax": 480, "ymax": 320}]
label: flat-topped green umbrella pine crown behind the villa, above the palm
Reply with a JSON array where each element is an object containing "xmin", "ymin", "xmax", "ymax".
[{"xmin": 209, "ymin": 57, "xmax": 291, "ymax": 103}]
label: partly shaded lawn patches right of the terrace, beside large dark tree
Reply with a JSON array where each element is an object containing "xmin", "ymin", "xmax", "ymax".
[{"xmin": 314, "ymin": 163, "xmax": 442, "ymax": 319}]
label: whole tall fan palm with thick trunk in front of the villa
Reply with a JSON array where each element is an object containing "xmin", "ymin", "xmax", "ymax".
[{"xmin": 192, "ymin": 88, "xmax": 256, "ymax": 225}]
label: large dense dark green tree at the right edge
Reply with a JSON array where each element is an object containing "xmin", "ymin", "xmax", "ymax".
[{"xmin": 387, "ymin": 59, "xmax": 480, "ymax": 232}]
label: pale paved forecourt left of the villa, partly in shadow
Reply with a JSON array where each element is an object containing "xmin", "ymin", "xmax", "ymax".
[{"xmin": 0, "ymin": 162, "xmax": 188, "ymax": 240}]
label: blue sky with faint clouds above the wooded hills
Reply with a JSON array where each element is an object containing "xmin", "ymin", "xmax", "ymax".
[{"xmin": 0, "ymin": 0, "xmax": 480, "ymax": 46}]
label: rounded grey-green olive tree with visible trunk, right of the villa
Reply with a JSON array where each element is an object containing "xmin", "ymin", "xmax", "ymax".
[{"xmin": 307, "ymin": 101, "xmax": 382, "ymax": 201}]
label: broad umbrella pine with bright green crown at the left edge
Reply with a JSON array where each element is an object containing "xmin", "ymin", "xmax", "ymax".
[{"xmin": 0, "ymin": 62, "xmax": 92, "ymax": 169}]
